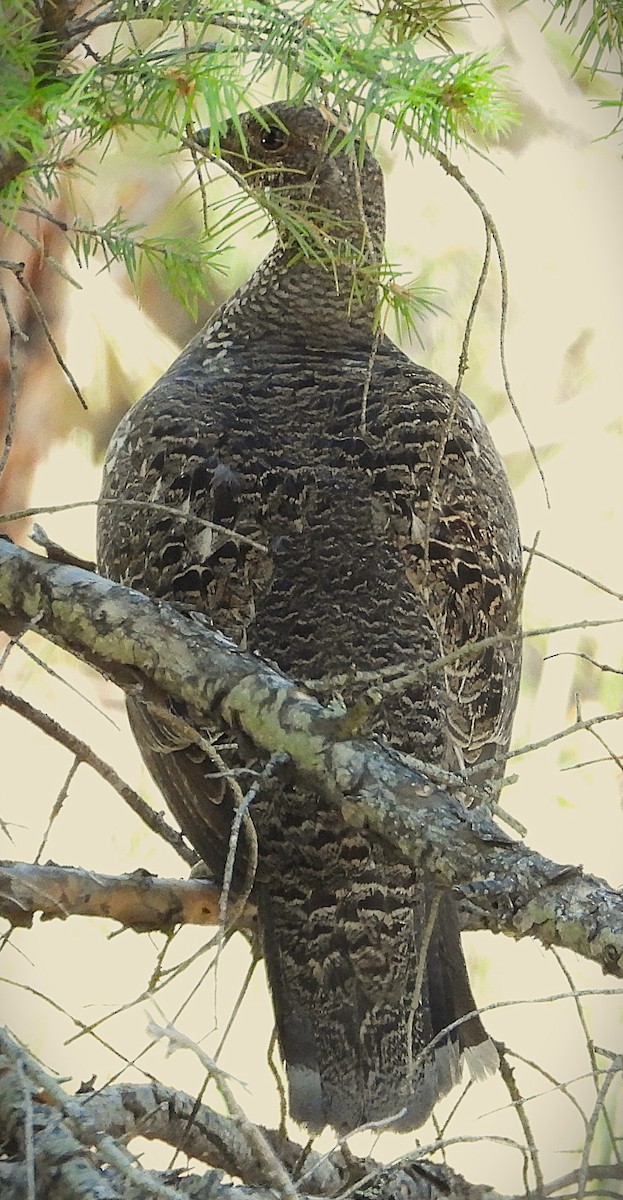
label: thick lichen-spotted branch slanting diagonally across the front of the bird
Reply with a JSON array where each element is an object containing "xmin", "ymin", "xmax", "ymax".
[{"xmin": 0, "ymin": 540, "xmax": 623, "ymax": 977}]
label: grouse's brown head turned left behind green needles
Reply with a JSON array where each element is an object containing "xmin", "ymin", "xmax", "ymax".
[{"xmin": 196, "ymin": 102, "xmax": 385, "ymax": 257}]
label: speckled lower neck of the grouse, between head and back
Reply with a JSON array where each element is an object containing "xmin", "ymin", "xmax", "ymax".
[{"xmin": 202, "ymin": 246, "xmax": 378, "ymax": 350}]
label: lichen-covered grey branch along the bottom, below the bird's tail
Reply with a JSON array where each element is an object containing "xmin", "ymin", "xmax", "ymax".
[{"xmin": 0, "ymin": 1030, "xmax": 497, "ymax": 1200}]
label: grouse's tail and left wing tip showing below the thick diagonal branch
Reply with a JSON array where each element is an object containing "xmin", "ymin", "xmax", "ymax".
[{"xmin": 128, "ymin": 700, "xmax": 497, "ymax": 1133}]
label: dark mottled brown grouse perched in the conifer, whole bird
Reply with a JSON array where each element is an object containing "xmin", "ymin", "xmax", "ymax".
[{"xmin": 97, "ymin": 103, "xmax": 521, "ymax": 1133}]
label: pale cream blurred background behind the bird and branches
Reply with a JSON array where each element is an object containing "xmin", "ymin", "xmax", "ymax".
[{"xmin": 0, "ymin": 0, "xmax": 623, "ymax": 1193}]
